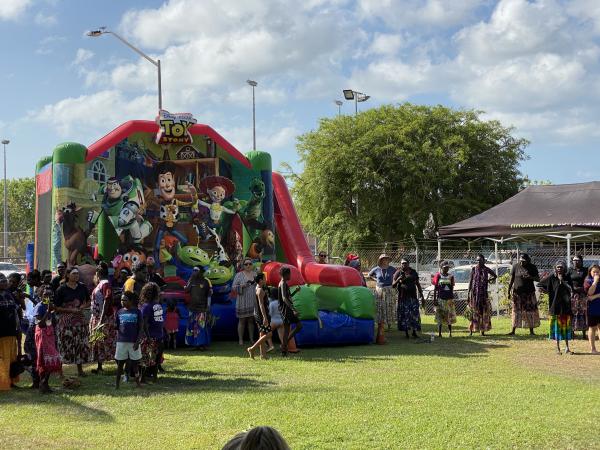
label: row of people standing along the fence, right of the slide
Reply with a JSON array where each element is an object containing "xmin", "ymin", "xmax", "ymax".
[{"xmin": 368, "ymin": 253, "xmax": 600, "ymax": 354}]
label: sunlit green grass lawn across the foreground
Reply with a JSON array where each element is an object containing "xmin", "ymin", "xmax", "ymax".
[{"xmin": 0, "ymin": 316, "xmax": 600, "ymax": 449}]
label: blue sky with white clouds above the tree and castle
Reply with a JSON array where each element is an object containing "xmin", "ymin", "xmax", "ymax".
[{"xmin": 0, "ymin": 0, "xmax": 600, "ymax": 183}]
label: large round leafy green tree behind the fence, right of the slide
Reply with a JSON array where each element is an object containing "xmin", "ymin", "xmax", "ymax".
[{"xmin": 291, "ymin": 103, "xmax": 528, "ymax": 250}]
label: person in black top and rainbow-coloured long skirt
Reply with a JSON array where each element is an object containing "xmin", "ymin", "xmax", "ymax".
[{"xmin": 538, "ymin": 261, "xmax": 573, "ymax": 355}]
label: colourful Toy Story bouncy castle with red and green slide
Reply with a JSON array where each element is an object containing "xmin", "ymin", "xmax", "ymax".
[{"xmin": 33, "ymin": 110, "xmax": 375, "ymax": 345}]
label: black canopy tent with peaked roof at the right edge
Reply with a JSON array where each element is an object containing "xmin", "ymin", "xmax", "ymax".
[{"xmin": 438, "ymin": 181, "xmax": 600, "ymax": 263}]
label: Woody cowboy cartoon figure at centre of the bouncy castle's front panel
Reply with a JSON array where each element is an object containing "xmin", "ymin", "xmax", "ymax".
[{"xmin": 154, "ymin": 161, "xmax": 198, "ymax": 263}]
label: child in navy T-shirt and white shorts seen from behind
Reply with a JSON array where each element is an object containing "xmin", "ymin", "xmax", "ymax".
[{"xmin": 115, "ymin": 291, "xmax": 143, "ymax": 389}]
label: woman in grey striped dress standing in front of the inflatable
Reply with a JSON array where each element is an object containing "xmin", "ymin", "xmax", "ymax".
[{"xmin": 232, "ymin": 258, "xmax": 256, "ymax": 345}]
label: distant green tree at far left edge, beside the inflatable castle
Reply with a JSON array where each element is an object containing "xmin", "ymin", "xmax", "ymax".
[{"xmin": 0, "ymin": 178, "xmax": 35, "ymax": 232}]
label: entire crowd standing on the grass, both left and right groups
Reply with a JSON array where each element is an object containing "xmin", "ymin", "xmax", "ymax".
[{"xmin": 0, "ymin": 253, "xmax": 600, "ymax": 392}]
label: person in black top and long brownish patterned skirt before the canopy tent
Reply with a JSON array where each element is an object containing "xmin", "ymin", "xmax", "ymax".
[{"xmin": 508, "ymin": 253, "xmax": 540, "ymax": 335}]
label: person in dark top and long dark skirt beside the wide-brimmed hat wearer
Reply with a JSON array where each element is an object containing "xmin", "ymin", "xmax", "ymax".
[{"xmin": 392, "ymin": 258, "xmax": 425, "ymax": 339}]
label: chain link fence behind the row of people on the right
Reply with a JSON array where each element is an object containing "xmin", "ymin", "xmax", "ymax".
[{"xmin": 316, "ymin": 240, "xmax": 600, "ymax": 316}]
